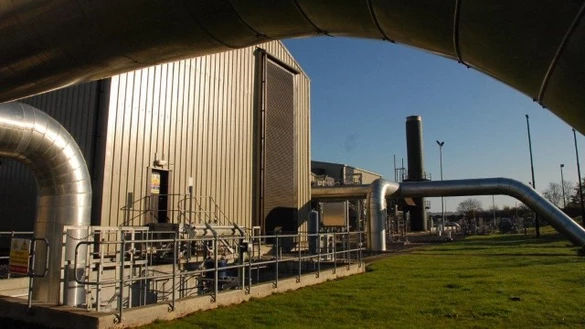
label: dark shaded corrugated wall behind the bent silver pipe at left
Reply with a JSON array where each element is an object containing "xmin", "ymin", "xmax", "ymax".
[{"xmin": 0, "ymin": 82, "xmax": 99, "ymax": 230}]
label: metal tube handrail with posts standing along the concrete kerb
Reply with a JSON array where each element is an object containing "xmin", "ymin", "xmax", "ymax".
[{"xmin": 73, "ymin": 232, "xmax": 364, "ymax": 321}]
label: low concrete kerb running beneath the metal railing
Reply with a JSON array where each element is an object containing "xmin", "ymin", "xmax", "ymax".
[{"xmin": 0, "ymin": 263, "xmax": 366, "ymax": 329}]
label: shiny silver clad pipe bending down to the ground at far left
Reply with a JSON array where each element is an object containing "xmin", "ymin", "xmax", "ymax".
[{"xmin": 0, "ymin": 103, "xmax": 91, "ymax": 306}]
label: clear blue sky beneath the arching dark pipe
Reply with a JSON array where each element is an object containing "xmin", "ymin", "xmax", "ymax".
[{"xmin": 284, "ymin": 37, "xmax": 585, "ymax": 211}]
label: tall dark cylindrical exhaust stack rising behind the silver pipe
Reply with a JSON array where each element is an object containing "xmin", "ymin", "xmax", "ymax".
[{"xmin": 405, "ymin": 115, "xmax": 428, "ymax": 232}]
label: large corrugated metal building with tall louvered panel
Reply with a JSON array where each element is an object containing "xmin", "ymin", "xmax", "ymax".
[{"xmin": 0, "ymin": 41, "xmax": 310, "ymax": 233}]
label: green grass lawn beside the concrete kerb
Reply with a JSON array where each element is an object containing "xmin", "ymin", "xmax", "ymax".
[{"xmin": 140, "ymin": 230, "xmax": 585, "ymax": 329}]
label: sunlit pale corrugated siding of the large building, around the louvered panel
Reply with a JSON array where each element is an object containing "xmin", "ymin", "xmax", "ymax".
[{"xmin": 102, "ymin": 41, "xmax": 310, "ymax": 227}]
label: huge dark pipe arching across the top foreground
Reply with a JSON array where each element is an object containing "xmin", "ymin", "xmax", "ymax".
[{"xmin": 0, "ymin": 0, "xmax": 585, "ymax": 132}]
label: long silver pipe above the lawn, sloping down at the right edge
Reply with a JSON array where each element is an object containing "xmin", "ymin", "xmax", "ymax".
[{"xmin": 394, "ymin": 178, "xmax": 585, "ymax": 246}]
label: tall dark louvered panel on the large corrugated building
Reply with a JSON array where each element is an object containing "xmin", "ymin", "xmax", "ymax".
[{"xmin": 264, "ymin": 60, "xmax": 297, "ymax": 232}]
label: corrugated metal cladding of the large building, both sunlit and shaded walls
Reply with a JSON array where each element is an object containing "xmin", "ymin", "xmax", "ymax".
[{"xmin": 0, "ymin": 41, "xmax": 310, "ymax": 230}]
